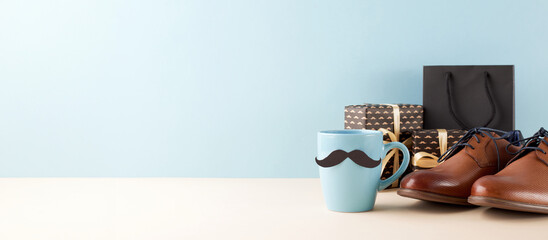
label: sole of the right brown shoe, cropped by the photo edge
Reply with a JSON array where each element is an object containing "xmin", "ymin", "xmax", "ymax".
[{"xmin": 468, "ymin": 196, "xmax": 548, "ymax": 214}]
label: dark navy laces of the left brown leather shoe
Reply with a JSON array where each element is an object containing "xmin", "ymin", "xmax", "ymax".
[{"xmin": 438, "ymin": 127, "xmax": 521, "ymax": 171}]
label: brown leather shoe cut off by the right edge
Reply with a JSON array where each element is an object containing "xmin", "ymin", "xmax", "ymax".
[{"xmin": 468, "ymin": 128, "xmax": 548, "ymax": 214}]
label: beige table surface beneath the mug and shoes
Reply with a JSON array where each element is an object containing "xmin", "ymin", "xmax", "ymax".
[{"xmin": 0, "ymin": 178, "xmax": 548, "ymax": 240}]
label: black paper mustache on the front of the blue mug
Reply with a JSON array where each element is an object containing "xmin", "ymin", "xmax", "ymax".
[{"xmin": 316, "ymin": 149, "xmax": 381, "ymax": 168}]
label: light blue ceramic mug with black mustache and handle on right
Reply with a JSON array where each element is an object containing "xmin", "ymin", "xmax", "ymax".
[{"xmin": 316, "ymin": 130, "xmax": 409, "ymax": 212}]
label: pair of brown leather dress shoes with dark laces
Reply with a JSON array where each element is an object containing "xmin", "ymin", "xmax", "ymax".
[{"xmin": 398, "ymin": 128, "xmax": 548, "ymax": 214}]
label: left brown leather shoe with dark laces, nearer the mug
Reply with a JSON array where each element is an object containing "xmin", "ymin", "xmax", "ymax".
[{"xmin": 398, "ymin": 128, "xmax": 521, "ymax": 205}]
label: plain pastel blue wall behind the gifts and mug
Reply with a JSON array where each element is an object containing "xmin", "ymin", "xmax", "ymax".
[{"xmin": 0, "ymin": 0, "xmax": 548, "ymax": 177}]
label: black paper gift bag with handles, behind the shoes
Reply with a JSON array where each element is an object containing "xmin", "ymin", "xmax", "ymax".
[{"xmin": 423, "ymin": 65, "xmax": 514, "ymax": 131}]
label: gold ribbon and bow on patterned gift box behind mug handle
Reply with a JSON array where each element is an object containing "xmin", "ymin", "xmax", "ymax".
[{"xmin": 378, "ymin": 104, "xmax": 412, "ymax": 187}]
